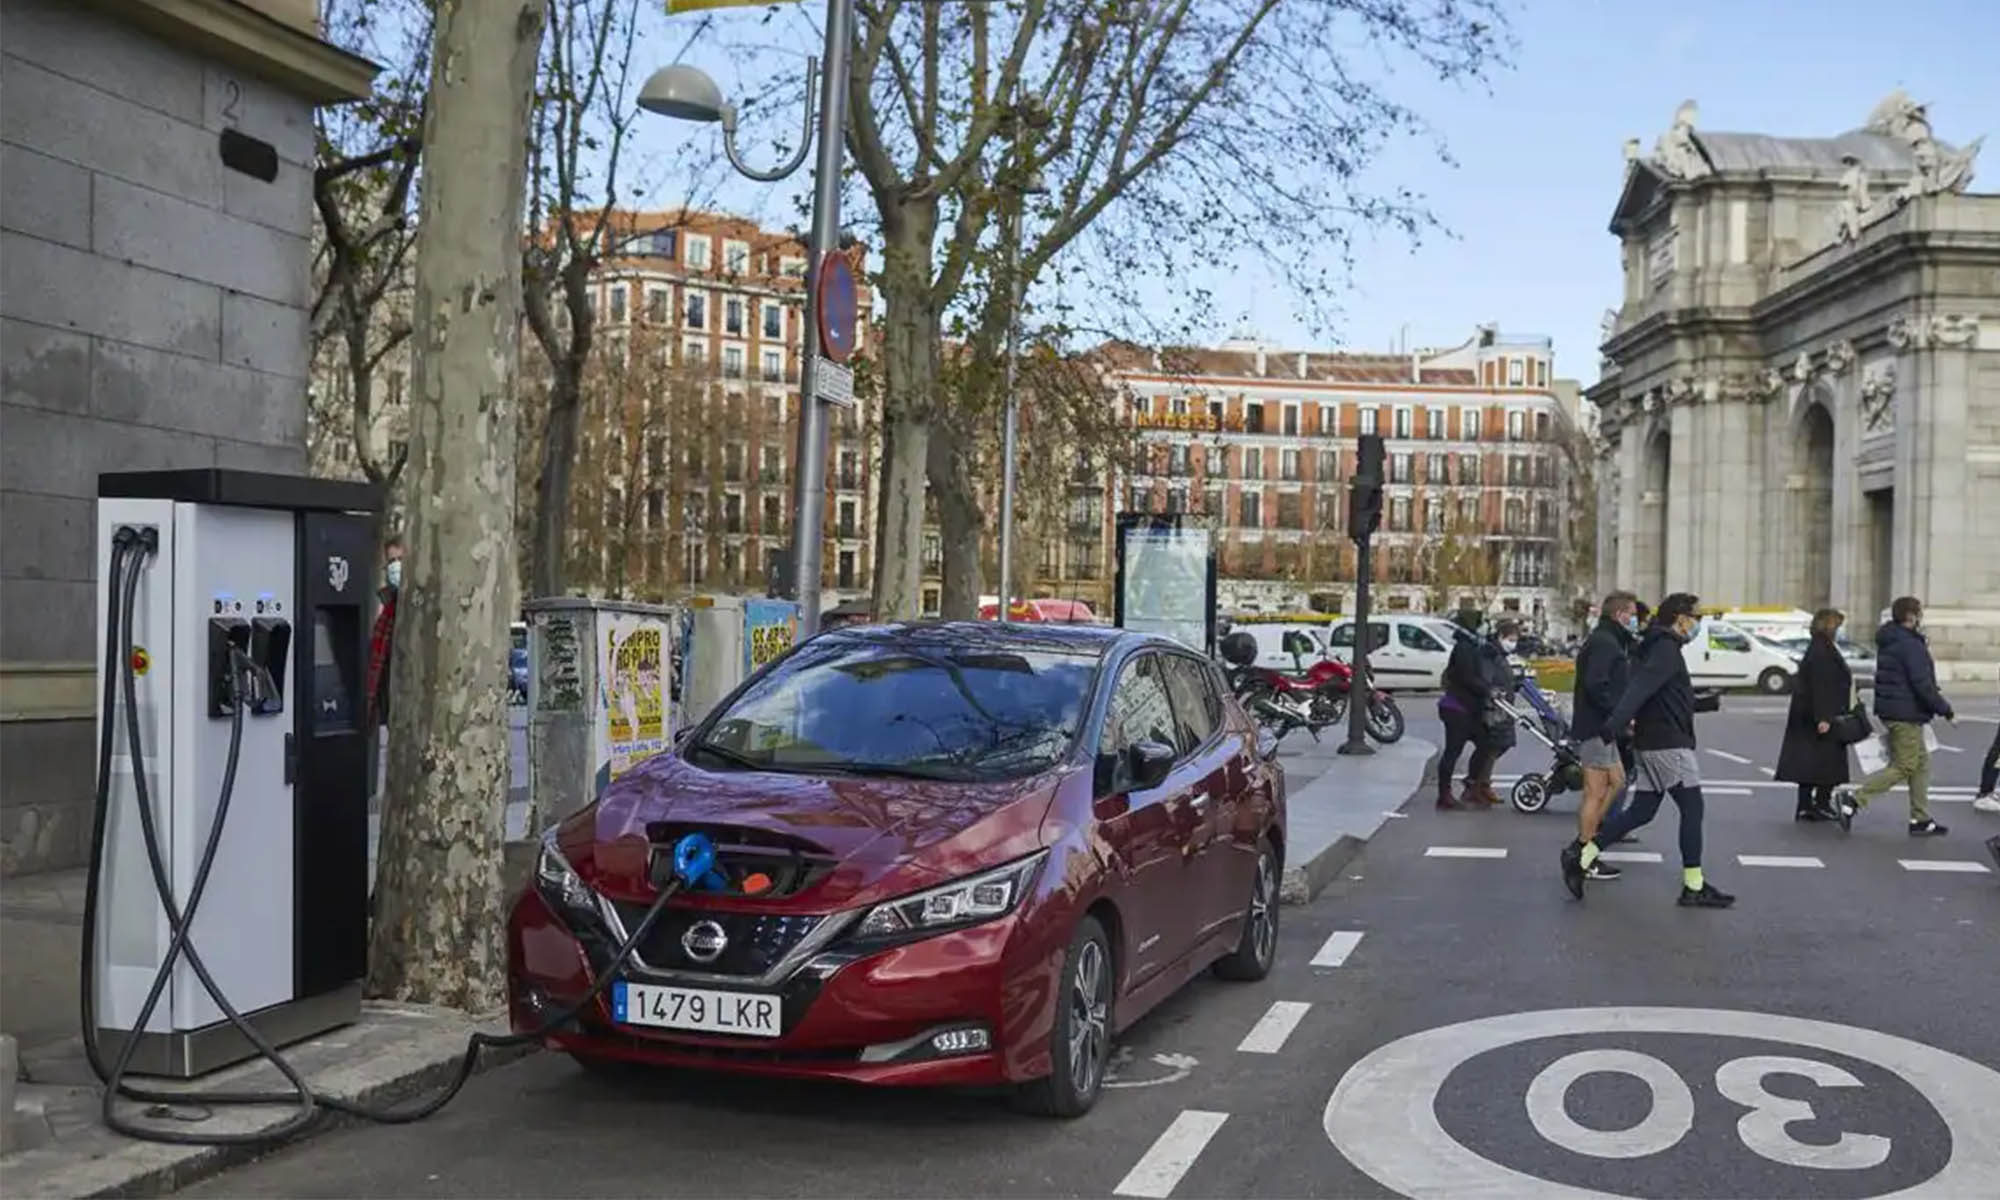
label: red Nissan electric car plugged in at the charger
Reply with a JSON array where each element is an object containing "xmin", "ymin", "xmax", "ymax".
[{"xmin": 508, "ymin": 622, "xmax": 1284, "ymax": 1116}]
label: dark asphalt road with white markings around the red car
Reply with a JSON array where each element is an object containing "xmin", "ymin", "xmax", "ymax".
[{"xmin": 196, "ymin": 698, "xmax": 2000, "ymax": 1198}]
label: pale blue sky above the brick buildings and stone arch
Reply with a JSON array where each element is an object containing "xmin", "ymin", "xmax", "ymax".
[{"xmin": 616, "ymin": 0, "xmax": 2000, "ymax": 384}]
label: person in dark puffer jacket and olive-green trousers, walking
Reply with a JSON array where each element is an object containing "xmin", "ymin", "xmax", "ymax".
[{"xmin": 1834, "ymin": 596, "xmax": 1956, "ymax": 838}]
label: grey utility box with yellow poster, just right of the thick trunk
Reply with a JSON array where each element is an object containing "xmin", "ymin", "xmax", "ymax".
[{"xmin": 524, "ymin": 596, "xmax": 678, "ymax": 836}]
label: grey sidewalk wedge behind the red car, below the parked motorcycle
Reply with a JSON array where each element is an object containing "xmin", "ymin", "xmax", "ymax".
[{"xmin": 1278, "ymin": 730, "xmax": 1438, "ymax": 904}]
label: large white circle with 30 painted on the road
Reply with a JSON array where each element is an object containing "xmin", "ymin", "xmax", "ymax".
[{"xmin": 1320, "ymin": 1008, "xmax": 2000, "ymax": 1200}]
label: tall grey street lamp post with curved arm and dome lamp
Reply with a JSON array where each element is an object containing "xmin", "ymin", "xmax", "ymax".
[{"xmin": 638, "ymin": 0, "xmax": 854, "ymax": 640}]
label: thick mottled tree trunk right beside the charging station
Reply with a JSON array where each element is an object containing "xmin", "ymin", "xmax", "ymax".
[{"xmin": 368, "ymin": 0, "xmax": 546, "ymax": 1010}]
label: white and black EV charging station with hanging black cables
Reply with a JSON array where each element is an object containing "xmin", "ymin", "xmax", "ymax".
[{"xmin": 84, "ymin": 470, "xmax": 378, "ymax": 1078}]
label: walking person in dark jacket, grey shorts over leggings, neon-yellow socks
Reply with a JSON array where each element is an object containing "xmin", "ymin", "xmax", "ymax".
[{"xmin": 1562, "ymin": 592, "xmax": 1736, "ymax": 908}]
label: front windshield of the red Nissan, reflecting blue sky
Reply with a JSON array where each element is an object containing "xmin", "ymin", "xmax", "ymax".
[{"xmin": 688, "ymin": 636, "xmax": 1098, "ymax": 780}]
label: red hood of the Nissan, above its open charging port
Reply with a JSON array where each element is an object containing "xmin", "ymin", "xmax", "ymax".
[{"xmin": 572, "ymin": 752, "xmax": 1060, "ymax": 904}]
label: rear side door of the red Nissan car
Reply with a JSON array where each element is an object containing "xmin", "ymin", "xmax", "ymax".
[{"xmin": 1162, "ymin": 654, "xmax": 1256, "ymax": 940}]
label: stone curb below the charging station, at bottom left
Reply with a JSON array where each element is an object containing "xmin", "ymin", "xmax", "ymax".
[{"xmin": 6, "ymin": 1026, "xmax": 536, "ymax": 1198}]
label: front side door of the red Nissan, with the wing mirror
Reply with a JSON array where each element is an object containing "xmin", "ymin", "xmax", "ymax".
[{"xmin": 1096, "ymin": 650, "xmax": 1200, "ymax": 988}]
